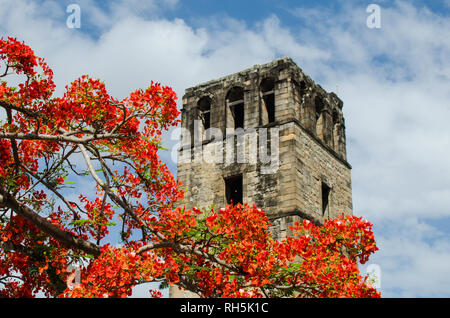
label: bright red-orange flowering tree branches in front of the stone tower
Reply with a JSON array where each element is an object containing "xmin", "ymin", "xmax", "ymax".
[{"xmin": 0, "ymin": 38, "xmax": 380, "ymax": 297}]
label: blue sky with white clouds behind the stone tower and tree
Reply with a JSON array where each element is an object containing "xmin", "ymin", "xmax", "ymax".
[{"xmin": 0, "ymin": 0, "xmax": 450, "ymax": 297}]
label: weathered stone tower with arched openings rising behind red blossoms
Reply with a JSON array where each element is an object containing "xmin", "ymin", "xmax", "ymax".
[{"xmin": 170, "ymin": 57, "xmax": 352, "ymax": 297}]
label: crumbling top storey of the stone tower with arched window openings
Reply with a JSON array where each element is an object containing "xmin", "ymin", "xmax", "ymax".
[{"xmin": 182, "ymin": 57, "xmax": 348, "ymax": 165}]
